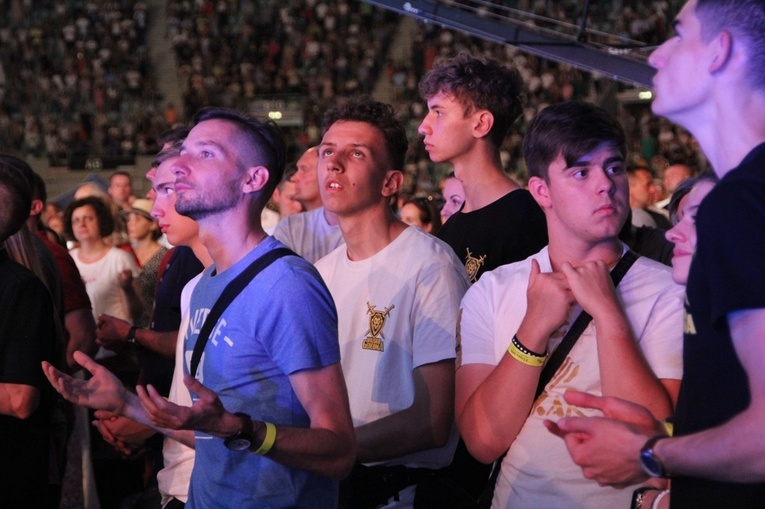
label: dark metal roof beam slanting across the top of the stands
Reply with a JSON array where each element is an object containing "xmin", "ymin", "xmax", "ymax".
[{"xmin": 365, "ymin": 0, "xmax": 654, "ymax": 88}]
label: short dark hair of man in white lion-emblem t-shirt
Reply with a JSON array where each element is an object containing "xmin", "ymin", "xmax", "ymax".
[{"xmin": 321, "ymin": 95, "xmax": 409, "ymax": 171}]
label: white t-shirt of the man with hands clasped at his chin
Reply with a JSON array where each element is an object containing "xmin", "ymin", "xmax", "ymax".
[{"xmin": 458, "ymin": 244, "xmax": 684, "ymax": 509}]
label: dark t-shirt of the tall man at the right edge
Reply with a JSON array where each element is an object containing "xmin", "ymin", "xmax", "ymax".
[{"xmin": 672, "ymin": 144, "xmax": 765, "ymax": 509}]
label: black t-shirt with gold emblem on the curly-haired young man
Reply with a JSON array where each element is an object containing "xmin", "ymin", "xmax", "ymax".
[{"xmin": 438, "ymin": 189, "xmax": 547, "ymax": 282}]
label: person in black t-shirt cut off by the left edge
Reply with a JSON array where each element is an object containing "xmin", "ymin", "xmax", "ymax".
[{"xmin": 0, "ymin": 161, "xmax": 55, "ymax": 507}]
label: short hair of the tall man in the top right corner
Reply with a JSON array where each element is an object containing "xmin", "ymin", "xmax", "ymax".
[{"xmin": 696, "ymin": 0, "xmax": 765, "ymax": 90}]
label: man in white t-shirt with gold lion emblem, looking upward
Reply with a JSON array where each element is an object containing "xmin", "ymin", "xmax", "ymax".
[{"xmin": 316, "ymin": 98, "xmax": 469, "ymax": 507}]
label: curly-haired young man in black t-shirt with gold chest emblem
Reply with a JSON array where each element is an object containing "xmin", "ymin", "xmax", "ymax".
[{"xmin": 418, "ymin": 53, "xmax": 547, "ymax": 282}]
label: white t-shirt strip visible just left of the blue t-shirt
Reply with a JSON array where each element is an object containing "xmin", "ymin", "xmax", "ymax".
[{"xmin": 157, "ymin": 273, "xmax": 202, "ymax": 506}]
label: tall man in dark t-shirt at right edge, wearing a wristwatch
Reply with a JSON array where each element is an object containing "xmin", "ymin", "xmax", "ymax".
[{"xmin": 558, "ymin": 0, "xmax": 765, "ymax": 509}]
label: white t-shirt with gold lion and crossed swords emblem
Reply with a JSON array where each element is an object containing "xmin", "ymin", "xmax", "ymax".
[{"xmin": 316, "ymin": 227, "xmax": 469, "ymax": 468}]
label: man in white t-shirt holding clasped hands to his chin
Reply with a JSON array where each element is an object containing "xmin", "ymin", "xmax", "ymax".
[{"xmin": 455, "ymin": 102, "xmax": 683, "ymax": 508}]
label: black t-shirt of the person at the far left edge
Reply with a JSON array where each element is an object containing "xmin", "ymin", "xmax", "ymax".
[{"xmin": 0, "ymin": 249, "xmax": 55, "ymax": 507}]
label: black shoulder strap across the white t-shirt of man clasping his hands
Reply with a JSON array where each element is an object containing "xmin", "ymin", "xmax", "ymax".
[{"xmin": 478, "ymin": 249, "xmax": 640, "ymax": 507}]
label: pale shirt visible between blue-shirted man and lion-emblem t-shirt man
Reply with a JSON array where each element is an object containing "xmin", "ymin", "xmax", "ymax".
[{"xmin": 274, "ymin": 207, "xmax": 345, "ymax": 263}]
